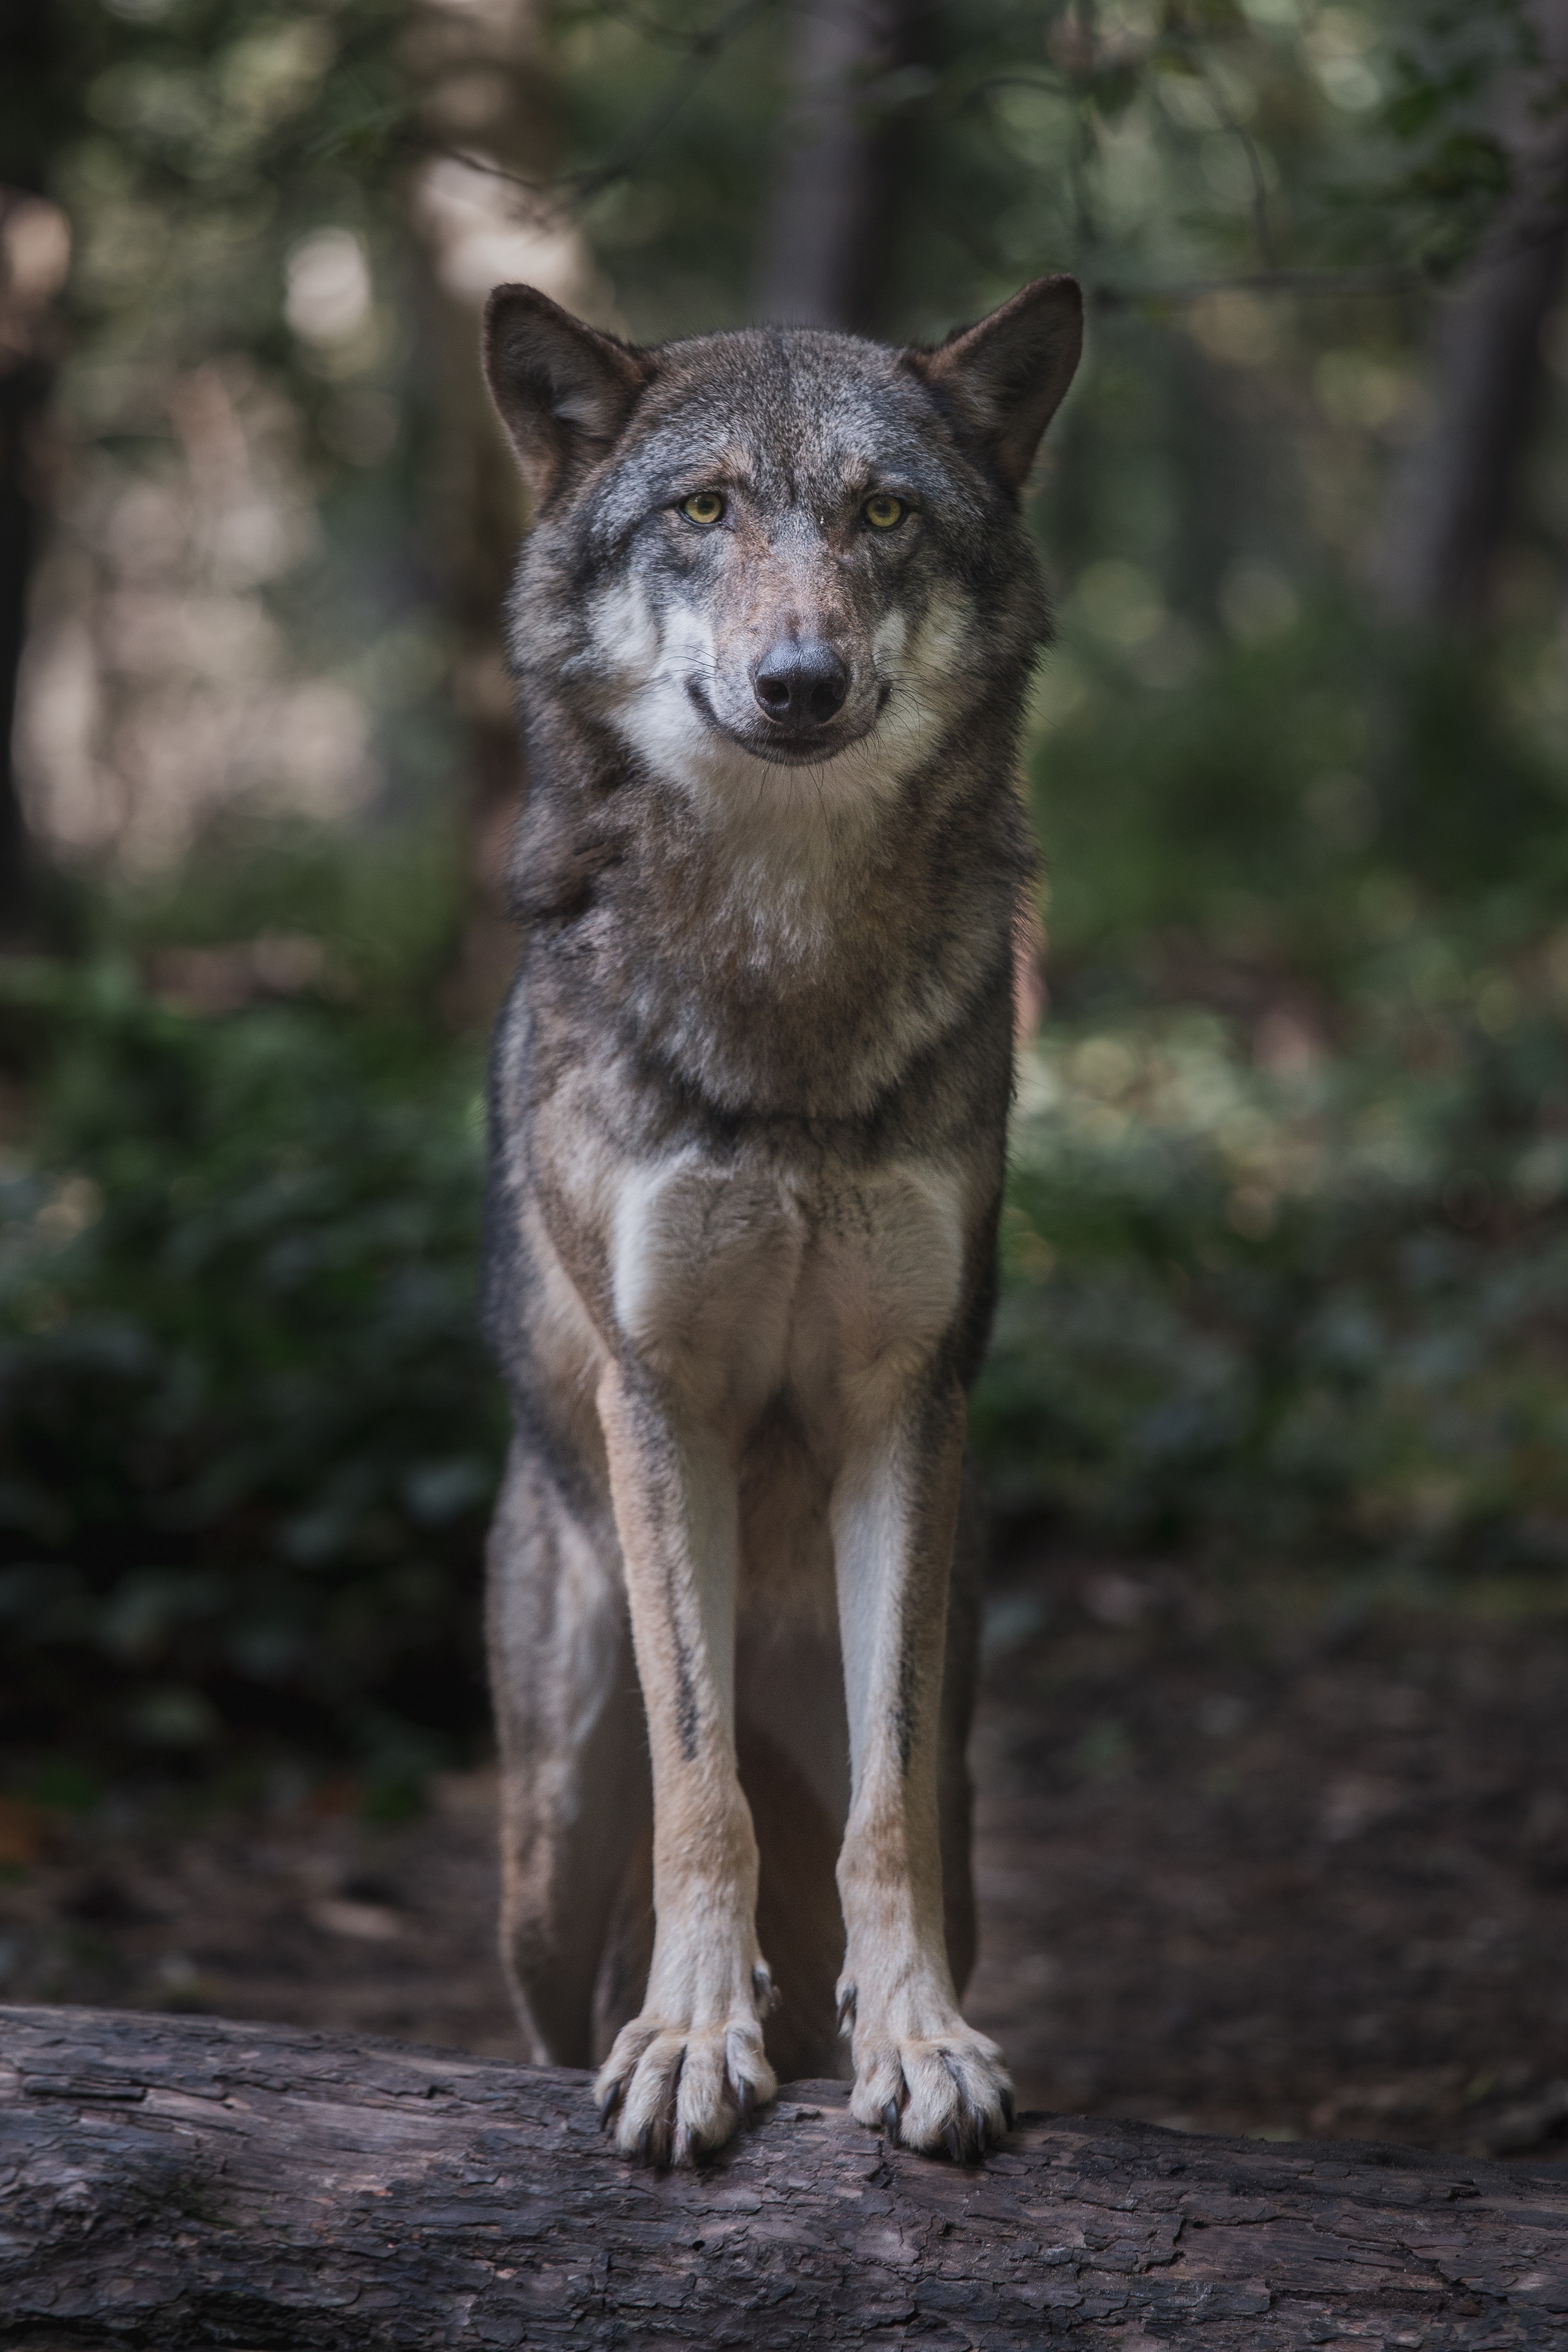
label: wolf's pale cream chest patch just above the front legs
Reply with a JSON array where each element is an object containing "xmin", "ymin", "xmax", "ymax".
[{"xmin": 609, "ymin": 1152, "xmax": 969, "ymax": 1437}]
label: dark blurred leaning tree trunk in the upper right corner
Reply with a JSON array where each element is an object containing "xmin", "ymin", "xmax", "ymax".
[{"xmin": 1373, "ymin": 0, "xmax": 1568, "ymax": 630}]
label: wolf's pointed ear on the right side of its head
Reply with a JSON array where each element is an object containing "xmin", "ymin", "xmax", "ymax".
[{"xmin": 910, "ymin": 278, "xmax": 1084, "ymax": 489}]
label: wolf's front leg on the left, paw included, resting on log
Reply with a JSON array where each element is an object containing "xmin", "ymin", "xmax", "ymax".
[{"xmin": 597, "ymin": 1367, "xmax": 778, "ymax": 2164}]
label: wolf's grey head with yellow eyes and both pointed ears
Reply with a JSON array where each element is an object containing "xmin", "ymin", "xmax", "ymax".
[{"xmin": 484, "ymin": 278, "xmax": 1081, "ymax": 804}]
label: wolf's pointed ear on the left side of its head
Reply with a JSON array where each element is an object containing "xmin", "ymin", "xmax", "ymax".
[{"xmin": 484, "ymin": 287, "xmax": 656, "ymax": 505}]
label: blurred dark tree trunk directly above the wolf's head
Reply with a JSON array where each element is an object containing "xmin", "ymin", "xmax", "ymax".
[{"xmin": 757, "ymin": 0, "xmax": 910, "ymax": 334}]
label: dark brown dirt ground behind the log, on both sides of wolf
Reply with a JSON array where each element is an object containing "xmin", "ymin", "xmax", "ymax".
[{"xmin": 0, "ymin": 1557, "xmax": 1568, "ymax": 2164}]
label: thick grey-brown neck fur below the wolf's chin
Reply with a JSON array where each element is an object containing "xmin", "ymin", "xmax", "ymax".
[{"xmin": 590, "ymin": 748, "xmax": 1027, "ymax": 1117}]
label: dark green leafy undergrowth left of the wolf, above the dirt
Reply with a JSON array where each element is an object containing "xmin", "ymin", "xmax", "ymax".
[{"xmin": 0, "ymin": 917, "xmax": 503, "ymax": 1783}]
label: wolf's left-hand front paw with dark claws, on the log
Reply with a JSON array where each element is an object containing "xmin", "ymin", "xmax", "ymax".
[{"xmin": 595, "ymin": 2013, "xmax": 778, "ymax": 2166}]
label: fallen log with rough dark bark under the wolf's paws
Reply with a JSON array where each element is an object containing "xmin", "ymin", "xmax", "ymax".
[{"xmin": 0, "ymin": 2009, "xmax": 1568, "ymax": 2352}]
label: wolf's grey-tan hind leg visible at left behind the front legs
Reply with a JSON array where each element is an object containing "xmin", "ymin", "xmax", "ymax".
[{"xmin": 489, "ymin": 1442, "xmax": 651, "ymax": 2065}]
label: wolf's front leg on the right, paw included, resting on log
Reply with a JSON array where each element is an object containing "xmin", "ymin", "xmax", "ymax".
[{"xmin": 832, "ymin": 1383, "xmax": 1013, "ymax": 2157}]
